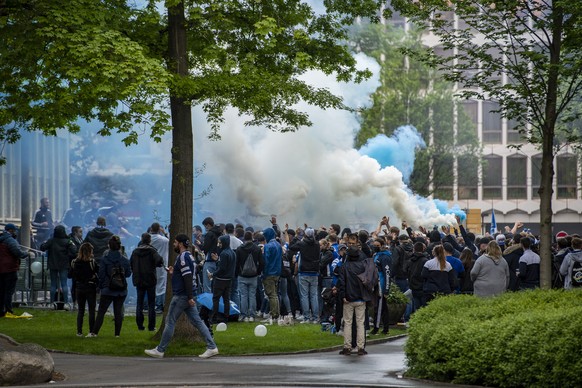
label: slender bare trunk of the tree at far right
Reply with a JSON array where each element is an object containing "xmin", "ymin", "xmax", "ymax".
[{"xmin": 539, "ymin": 6, "xmax": 564, "ymax": 289}]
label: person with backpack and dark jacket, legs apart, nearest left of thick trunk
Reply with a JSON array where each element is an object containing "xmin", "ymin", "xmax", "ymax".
[{"xmin": 90, "ymin": 235, "xmax": 131, "ymax": 337}]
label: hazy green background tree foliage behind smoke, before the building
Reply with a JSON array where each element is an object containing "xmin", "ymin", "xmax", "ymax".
[{"xmin": 353, "ymin": 24, "xmax": 479, "ymax": 199}]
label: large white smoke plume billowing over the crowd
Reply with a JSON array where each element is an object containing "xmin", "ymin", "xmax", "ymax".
[{"xmin": 194, "ymin": 55, "xmax": 455, "ymax": 227}]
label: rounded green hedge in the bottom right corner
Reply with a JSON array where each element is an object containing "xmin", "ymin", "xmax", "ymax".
[{"xmin": 405, "ymin": 290, "xmax": 582, "ymax": 387}]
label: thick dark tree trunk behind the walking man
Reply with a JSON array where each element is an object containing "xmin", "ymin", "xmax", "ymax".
[{"xmin": 156, "ymin": 2, "xmax": 201, "ymax": 340}]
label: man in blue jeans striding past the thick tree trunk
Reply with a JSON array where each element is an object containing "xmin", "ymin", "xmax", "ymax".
[{"xmin": 145, "ymin": 234, "xmax": 218, "ymax": 358}]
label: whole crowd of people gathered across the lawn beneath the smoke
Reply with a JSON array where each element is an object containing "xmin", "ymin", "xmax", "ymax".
[{"xmin": 0, "ymin": 198, "xmax": 582, "ymax": 357}]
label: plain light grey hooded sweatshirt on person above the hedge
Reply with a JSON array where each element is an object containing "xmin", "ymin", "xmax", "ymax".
[{"xmin": 471, "ymin": 254, "xmax": 509, "ymax": 297}]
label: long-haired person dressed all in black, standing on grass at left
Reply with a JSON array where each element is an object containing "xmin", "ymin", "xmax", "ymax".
[{"xmin": 71, "ymin": 243, "xmax": 99, "ymax": 337}]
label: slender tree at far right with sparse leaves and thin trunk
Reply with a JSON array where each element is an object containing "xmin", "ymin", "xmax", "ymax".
[{"xmin": 392, "ymin": 0, "xmax": 582, "ymax": 287}]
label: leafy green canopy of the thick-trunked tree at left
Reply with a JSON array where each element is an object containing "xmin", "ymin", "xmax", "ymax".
[{"xmin": 0, "ymin": 0, "xmax": 392, "ymax": 163}]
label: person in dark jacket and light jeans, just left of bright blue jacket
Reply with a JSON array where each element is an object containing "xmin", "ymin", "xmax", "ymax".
[{"xmin": 236, "ymin": 231, "xmax": 265, "ymax": 322}]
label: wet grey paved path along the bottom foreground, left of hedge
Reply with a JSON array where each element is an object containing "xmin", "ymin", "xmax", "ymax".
[{"xmin": 43, "ymin": 338, "xmax": 458, "ymax": 387}]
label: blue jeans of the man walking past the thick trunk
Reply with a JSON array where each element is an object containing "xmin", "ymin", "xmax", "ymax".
[{"xmin": 158, "ymin": 295, "xmax": 216, "ymax": 353}]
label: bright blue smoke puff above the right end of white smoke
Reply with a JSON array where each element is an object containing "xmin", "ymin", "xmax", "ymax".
[{"xmin": 359, "ymin": 125, "xmax": 426, "ymax": 183}]
